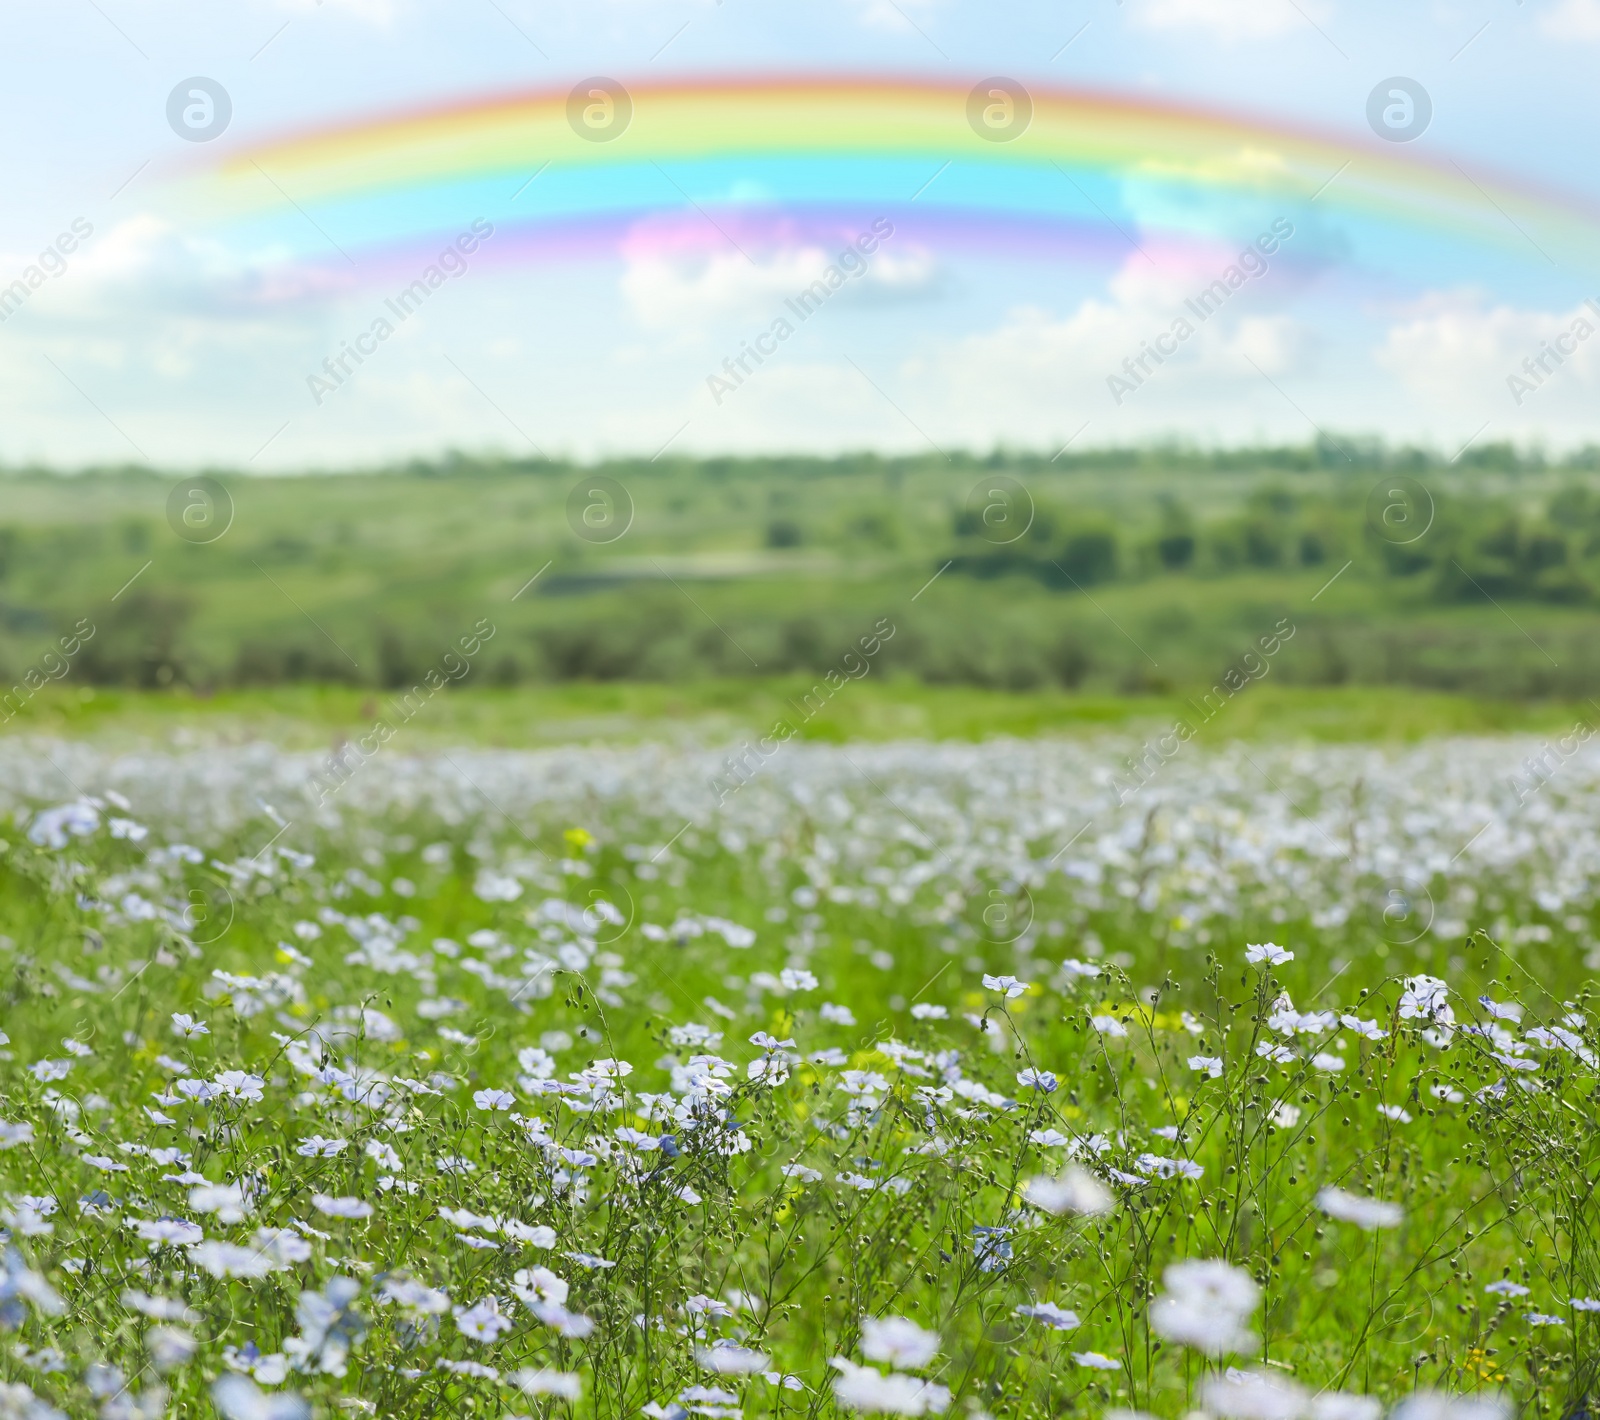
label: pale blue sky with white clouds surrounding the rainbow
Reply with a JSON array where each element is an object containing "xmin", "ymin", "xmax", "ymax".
[{"xmin": 0, "ymin": 0, "xmax": 1600, "ymax": 470}]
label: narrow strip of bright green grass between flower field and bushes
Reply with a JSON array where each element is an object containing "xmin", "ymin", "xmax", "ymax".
[{"xmin": 0, "ymin": 675, "xmax": 1597, "ymax": 750}]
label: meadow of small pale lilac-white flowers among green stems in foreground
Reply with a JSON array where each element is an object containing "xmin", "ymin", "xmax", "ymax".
[{"xmin": 0, "ymin": 739, "xmax": 1600, "ymax": 1420}]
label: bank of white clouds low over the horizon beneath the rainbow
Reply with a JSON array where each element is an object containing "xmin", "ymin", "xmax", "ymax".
[{"xmin": 9, "ymin": 217, "xmax": 1600, "ymax": 467}]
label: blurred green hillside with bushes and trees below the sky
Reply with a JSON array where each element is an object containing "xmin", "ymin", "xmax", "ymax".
[{"xmin": 9, "ymin": 440, "xmax": 1600, "ymax": 699}]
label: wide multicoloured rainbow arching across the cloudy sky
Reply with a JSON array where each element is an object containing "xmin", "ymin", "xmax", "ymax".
[{"xmin": 174, "ymin": 78, "xmax": 1600, "ymax": 291}]
